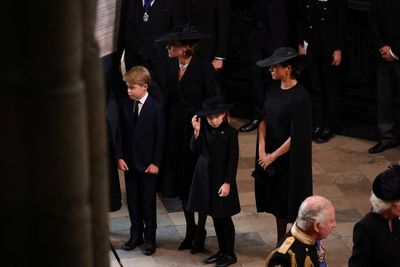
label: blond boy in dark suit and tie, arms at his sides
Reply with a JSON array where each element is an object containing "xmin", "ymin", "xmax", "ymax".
[{"xmin": 116, "ymin": 66, "xmax": 165, "ymax": 255}]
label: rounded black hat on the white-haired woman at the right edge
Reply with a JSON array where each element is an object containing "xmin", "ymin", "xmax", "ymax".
[{"xmin": 372, "ymin": 164, "xmax": 400, "ymax": 201}]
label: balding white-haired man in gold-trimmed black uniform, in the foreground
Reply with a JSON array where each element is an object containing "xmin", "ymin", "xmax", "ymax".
[{"xmin": 265, "ymin": 196, "xmax": 336, "ymax": 267}]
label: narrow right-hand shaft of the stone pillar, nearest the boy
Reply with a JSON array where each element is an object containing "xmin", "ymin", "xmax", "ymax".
[{"xmin": 82, "ymin": 0, "xmax": 109, "ymax": 267}]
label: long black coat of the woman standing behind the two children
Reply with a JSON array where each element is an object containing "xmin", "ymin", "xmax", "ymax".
[{"xmin": 160, "ymin": 56, "xmax": 216, "ymax": 200}]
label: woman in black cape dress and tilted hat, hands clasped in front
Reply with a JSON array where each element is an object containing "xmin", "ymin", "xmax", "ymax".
[{"xmin": 253, "ymin": 47, "xmax": 312, "ymax": 245}]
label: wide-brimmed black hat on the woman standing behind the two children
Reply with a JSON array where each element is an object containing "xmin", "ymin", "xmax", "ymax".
[{"xmin": 155, "ymin": 24, "xmax": 210, "ymax": 42}]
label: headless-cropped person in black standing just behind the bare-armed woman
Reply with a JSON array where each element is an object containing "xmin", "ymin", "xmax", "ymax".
[{"xmin": 239, "ymin": 0, "xmax": 289, "ymax": 132}]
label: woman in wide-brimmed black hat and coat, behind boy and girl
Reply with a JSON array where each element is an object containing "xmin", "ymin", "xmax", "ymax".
[{"xmin": 157, "ymin": 24, "xmax": 217, "ymax": 253}]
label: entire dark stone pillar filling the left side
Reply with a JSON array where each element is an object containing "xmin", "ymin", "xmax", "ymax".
[{"xmin": 0, "ymin": 0, "xmax": 108, "ymax": 267}]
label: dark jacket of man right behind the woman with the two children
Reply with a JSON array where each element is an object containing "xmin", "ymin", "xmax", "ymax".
[{"xmin": 180, "ymin": 0, "xmax": 231, "ymax": 61}]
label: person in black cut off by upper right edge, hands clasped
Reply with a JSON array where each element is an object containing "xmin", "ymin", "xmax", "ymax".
[{"xmin": 368, "ymin": 0, "xmax": 400, "ymax": 153}]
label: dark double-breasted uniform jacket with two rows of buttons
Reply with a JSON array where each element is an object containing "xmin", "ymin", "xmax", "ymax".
[{"xmin": 297, "ymin": 0, "xmax": 347, "ymax": 56}]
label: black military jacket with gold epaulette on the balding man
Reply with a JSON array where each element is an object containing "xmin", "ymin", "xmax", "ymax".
[{"xmin": 265, "ymin": 224, "xmax": 319, "ymax": 267}]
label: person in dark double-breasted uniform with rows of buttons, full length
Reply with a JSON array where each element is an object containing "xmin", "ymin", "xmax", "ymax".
[{"xmin": 297, "ymin": 0, "xmax": 347, "ymax": 143}]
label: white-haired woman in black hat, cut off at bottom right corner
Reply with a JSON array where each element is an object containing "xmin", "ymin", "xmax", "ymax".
[{"xmin": 349, "ymin": 164, "xmax": 400, "ymax": 267}]
